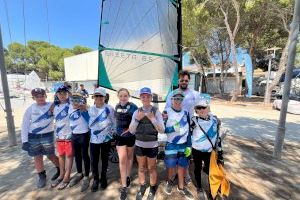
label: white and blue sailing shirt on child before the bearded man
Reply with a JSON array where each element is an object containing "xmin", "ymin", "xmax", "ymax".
[{"xmin": 165, "ymin": 108, "xmax": 190, "ymax": 144}]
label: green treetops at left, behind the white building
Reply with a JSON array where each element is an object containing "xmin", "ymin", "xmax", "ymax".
[{"xmin": 4, "ymin": 41, "xmax": 92, "ymax": 80}]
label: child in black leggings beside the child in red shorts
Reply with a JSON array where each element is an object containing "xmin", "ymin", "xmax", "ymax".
[{"xmin": 69, "ymin": 93, "xmax": 90, "ymax": 192}]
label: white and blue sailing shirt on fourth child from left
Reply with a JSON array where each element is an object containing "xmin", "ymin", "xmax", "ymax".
[{"xmin": 88, "ymin": 104, "xmax": 116, "ymax": 144}]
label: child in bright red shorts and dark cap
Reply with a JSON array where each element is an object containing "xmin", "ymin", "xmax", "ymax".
[{"xmin": 51, "ymin": 85, "xmax": 73, "ymax": 190}]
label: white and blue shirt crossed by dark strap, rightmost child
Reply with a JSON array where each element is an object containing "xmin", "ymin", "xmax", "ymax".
[{"xmin": 191, "ymin": 114, "xmax": 218, "ymax": 152}]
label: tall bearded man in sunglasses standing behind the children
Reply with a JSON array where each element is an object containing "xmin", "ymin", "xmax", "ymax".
[{"xmin": 162, "ymin": 70, "xmax": 200, "ymax": 188}]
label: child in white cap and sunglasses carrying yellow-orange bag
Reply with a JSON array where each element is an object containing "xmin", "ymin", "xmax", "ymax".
[{"xmin": 191, "ymin": 98, "xmax": 219, "ymax": 198}]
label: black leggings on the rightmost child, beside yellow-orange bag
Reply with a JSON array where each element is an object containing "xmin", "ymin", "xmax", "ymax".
[{"xmin": 192, "ymin": 148, "xmax": 211, "ymax": 188}]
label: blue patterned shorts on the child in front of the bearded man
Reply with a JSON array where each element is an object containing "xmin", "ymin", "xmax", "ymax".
[{"xmin": 165, "ymin": 142, "xmax": 189, "ymax": 168}]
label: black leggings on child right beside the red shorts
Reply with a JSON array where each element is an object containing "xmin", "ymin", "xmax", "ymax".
[{"xmin": 72, "ymin": 133, "xmax": 91, "ymax": 176}]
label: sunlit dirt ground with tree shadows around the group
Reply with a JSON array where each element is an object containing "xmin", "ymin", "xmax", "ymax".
[{"xmin": 0, "ymin": 95, "xmax": 300, "ymax": 200}]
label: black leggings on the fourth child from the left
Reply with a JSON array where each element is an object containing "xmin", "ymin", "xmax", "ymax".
[{"xmin": 90, "ymin": 142, "xmax": 110, "ymax": 180}]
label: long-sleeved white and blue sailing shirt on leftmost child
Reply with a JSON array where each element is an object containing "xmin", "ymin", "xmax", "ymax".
[{"xmin": 21, "ymin": 102, "xmax": 54, "ymax": 143}]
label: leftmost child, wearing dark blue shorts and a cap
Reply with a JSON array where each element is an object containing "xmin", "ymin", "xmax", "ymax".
[{"xmin": 21, "ymin": 88, "xmax": 60, "ymax": 188}]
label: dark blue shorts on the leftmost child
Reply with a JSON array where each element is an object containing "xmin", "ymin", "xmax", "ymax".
[{"xmin": 28, "ymin": 132, "xmax": 55, "ymax": 156}]
